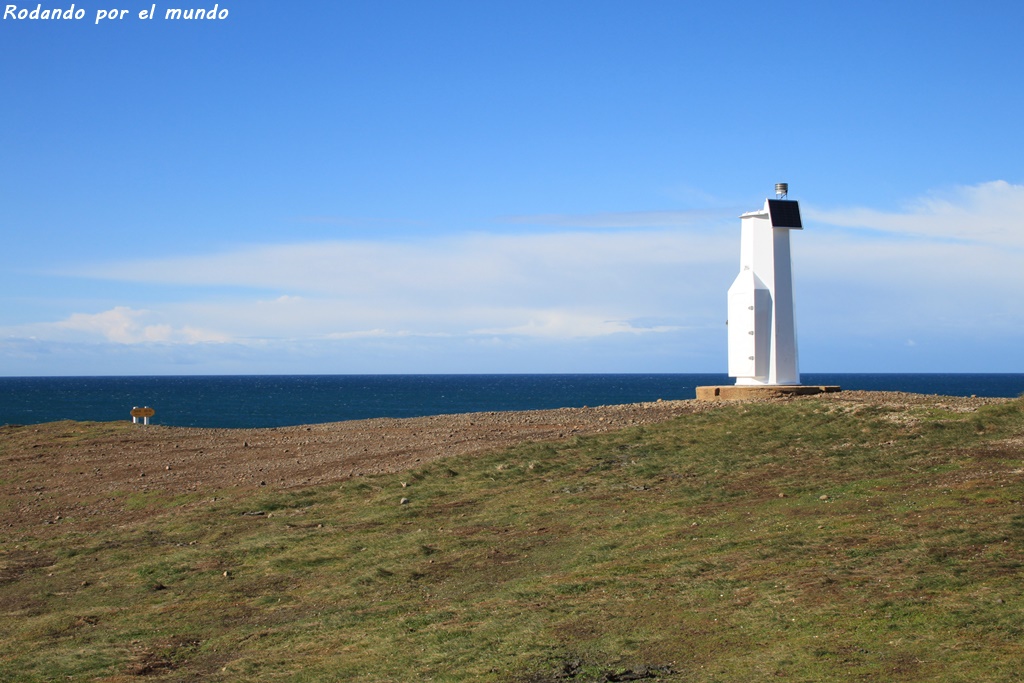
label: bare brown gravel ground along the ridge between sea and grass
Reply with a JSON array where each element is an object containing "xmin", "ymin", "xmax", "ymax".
[{"xmin": 0, "ymin": 391, "xmax": 1007, "ymax": 533}]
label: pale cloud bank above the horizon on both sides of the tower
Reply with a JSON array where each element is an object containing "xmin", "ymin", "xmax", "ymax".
[{"xmin": 0, "ymin": 180, "xmax": 1024, "ymax": 374}]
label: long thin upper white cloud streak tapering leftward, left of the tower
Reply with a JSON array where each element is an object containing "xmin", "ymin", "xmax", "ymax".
[{"xmin": 59, "ymin": 230, "xmax": 731, "ymax": 295}]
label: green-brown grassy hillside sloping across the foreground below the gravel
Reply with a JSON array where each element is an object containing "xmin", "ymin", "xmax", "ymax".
[{"xmin": 0, "ymin": 399, "xmax": 1024, "ymax": 683}]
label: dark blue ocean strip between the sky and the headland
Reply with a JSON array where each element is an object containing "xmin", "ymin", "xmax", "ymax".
[{"xmin": 0, "ymin": 373, "xmax": 1024, "ymax": 428}]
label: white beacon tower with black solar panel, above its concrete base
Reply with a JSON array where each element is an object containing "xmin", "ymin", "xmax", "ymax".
[{"xmin": 728, "ymin": 200, "xmax": 803, "ymax": 386}]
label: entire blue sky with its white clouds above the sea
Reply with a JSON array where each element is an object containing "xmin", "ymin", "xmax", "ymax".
[{"xmin": 0, "ymin": 0, "xmax": 1024, "ymax": 376}]
